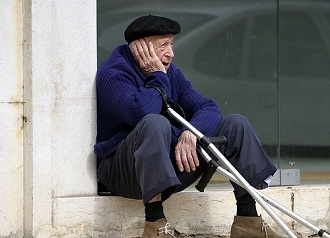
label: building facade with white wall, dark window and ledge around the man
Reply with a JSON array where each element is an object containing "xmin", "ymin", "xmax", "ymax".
[{"xmin": 0, "ymin": 0, "xmax": 330, "ymax": 237}]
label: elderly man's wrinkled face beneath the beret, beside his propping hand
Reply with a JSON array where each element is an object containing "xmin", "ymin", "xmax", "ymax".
[{"xmin": 145, "ymin": 35, "xmax": 174, "ymax": 71}]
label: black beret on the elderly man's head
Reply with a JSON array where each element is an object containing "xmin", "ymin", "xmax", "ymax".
[{"xmin": 124, "ymin": 14, "xmax": 181, "ymax": 44}]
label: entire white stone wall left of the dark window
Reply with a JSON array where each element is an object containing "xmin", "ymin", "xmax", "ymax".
[{"xmin": 0, "ymin": 0, "xmax": 97, "ymax": 237}]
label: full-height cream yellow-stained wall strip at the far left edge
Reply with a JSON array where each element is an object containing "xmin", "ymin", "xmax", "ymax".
[{"xmin": 0, "ymin": 0, "xmax": 23, "ymax": 237}]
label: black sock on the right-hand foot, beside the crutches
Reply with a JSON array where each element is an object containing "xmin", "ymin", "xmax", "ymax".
[{"xmin": 236, "ymin": 193, "xmax": 258, "ymax": 217}]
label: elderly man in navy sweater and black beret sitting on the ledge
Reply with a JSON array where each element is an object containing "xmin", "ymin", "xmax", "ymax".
[{"xmin": 94, "ymin": 15, "xmax": 277, "ymax": 237}]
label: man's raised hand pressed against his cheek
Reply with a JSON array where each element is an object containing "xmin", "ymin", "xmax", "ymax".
[{"xmin": 129, "ymin": 38, "xmax": 166, "ymax": 75}]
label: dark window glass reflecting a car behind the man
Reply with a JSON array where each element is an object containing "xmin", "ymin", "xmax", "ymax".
[{"xmin": 98, "ymin": 0, "xmax": 330, "ymax": 184}]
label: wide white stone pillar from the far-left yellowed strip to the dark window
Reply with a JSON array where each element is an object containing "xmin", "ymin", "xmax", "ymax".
[{"xmin": 23, "ymin": 0, "xmax": 96, "ymax": 237}]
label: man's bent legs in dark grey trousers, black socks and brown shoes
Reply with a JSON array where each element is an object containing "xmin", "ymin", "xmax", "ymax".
[{"xmin": 98, "ymin": 114, "xmax": 278, "ymax": 237}]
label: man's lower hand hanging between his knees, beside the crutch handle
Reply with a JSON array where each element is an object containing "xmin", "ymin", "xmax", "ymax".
[{"xmin": 175, "ymin": 130, "xmax": 199, "ymax": 172}]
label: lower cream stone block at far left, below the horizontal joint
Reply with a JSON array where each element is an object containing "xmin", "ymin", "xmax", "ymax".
[{"xmin": 0, "ymin": 103, "xmax": 23, "ymax": 237}]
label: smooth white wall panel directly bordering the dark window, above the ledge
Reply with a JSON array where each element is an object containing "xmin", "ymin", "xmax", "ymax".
[{"xmin": 51, "ymin": 0, "xmax": 97, "ymax": 197}]
